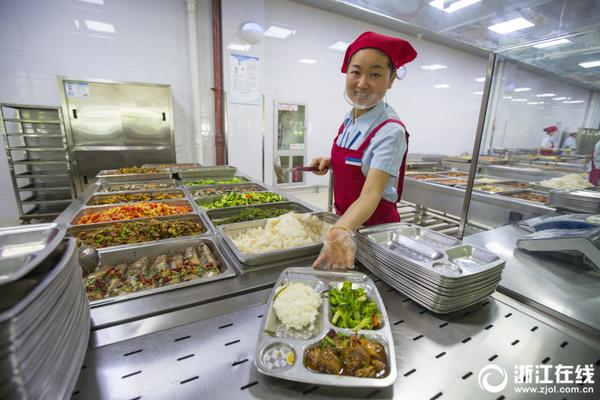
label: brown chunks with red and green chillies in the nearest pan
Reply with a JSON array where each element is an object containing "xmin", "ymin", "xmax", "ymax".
[{"xmin": 84, "ymin": 243, "xmax": 221, "ymax": 300}]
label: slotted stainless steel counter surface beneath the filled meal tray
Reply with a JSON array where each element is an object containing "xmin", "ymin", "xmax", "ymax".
[{"xmin": 72, "ymin": 275, "xmax": 600, "ymax": 400}]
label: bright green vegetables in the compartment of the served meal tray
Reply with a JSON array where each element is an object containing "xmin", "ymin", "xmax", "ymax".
[{"xmin": 329, "ymin": 281, "xmax": 383, "ymax": 330}]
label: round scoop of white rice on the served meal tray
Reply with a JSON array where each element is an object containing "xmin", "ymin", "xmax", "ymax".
[{"xmin": 273, "ymin": 282, "xmax": 321, "ymax": 330}]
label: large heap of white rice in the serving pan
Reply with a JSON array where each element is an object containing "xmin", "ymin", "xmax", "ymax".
[{"xmin": 231, "ymin": 212, "xmax": 331, "ymax": 254}]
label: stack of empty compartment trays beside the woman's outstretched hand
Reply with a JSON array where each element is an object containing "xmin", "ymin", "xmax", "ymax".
[{"xmin": 356, "ymin": 223, "xmax": 504, "ymax": 314}]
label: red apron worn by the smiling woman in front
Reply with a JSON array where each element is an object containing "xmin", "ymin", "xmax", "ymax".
[{"xmin": 331, "ymin": 119, "xmax": 408, "ymax": 225}]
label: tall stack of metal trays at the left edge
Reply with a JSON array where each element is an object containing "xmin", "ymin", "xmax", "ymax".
[{"xmin": 0, "ymin": 224, "xmax": 90, "ymax": 399}]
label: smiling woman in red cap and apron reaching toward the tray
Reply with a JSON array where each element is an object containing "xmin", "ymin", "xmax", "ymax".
[{"xmin": 310, "ymin": 32, "xmax": 417, "ymax": 270}]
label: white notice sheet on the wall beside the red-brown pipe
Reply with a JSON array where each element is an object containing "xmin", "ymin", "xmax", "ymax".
[{"xmin": 229, "ymin": 53, "xmax": 260, "ymax": 104}]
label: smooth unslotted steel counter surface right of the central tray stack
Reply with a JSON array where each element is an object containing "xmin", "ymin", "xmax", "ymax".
[{"xmin": 464, "ymin": 225, "xmax": 600, "ymax": 335}]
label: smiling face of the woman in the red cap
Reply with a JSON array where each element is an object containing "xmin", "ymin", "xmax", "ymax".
[{"xmin": 346, "ymin": 48, "xmax": 396, "ymax": 117}]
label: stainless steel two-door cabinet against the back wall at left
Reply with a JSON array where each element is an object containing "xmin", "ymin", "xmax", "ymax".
[{"xmin": 59, "ymin": 77, "xmax": 175, "ymax": 194}]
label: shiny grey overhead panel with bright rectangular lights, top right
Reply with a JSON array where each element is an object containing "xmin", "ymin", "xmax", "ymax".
[{"xmin": 295, "ymin": 0, "xmax": 600, "ymax": 90}]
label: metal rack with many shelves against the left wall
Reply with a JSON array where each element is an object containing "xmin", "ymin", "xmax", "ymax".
[{"xmin": 0, "ymin": 103, "xmax": 75, "ymax": 222}]
